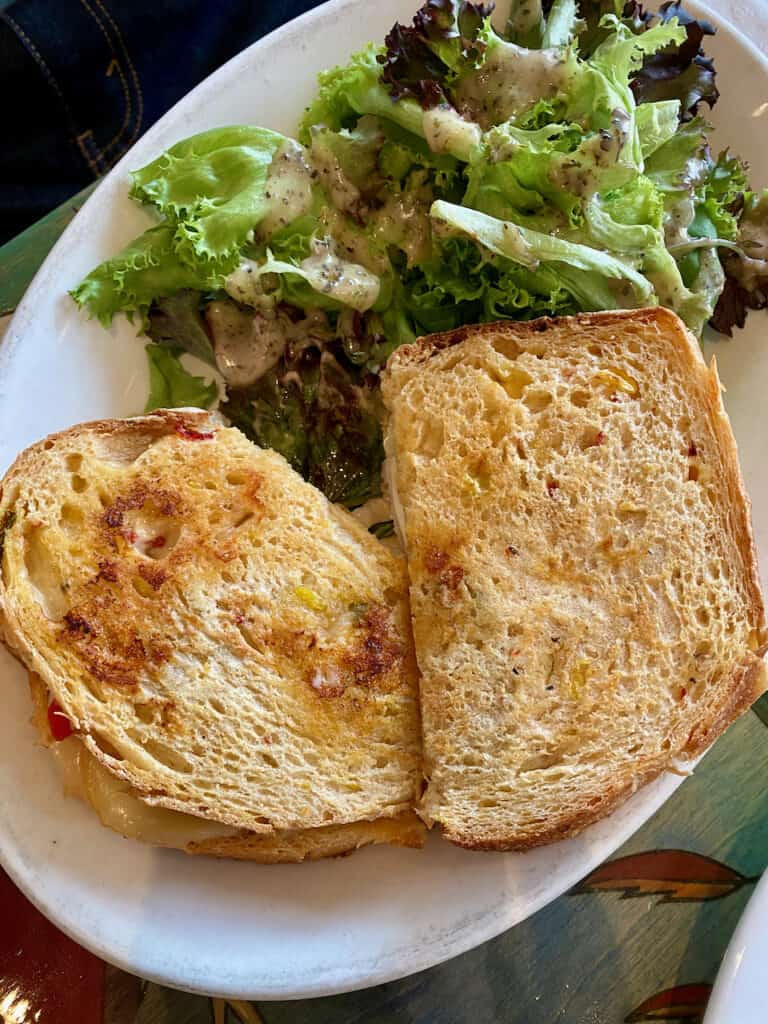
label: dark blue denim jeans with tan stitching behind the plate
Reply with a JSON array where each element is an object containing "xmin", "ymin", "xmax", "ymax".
[{"xmin": 0, "ymin": 0, "xmax": 319, "ymax": 244}]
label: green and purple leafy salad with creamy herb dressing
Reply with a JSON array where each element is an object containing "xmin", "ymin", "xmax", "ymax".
[{"xmin": 72, "ymin": 0, "xmax": 768, "ymax": 507}]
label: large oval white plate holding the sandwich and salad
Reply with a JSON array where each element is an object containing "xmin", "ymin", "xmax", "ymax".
[{"xmin": 0, "ymin": 0, "xmax": 768, "ymax": 998}]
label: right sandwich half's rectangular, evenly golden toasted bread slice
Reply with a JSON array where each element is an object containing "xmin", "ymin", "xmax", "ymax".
[{"xmin": 383, "ymin": 309, "xmax": 766, "ymax": 850}]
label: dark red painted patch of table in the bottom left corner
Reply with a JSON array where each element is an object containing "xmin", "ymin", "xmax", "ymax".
[{"xmin": 0, "ymin": 870, "xmax": 104, "ymax": 1024}]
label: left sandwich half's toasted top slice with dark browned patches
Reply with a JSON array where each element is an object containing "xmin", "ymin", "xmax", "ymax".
[{"xmin": 0, "ymin": 412, "xmax": 421, "ymax": 847}]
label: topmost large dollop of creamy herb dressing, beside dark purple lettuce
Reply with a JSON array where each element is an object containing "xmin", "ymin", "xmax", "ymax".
[{"xmin": 455, "ymin": 43, "xmax": 569, "ymax": 129}]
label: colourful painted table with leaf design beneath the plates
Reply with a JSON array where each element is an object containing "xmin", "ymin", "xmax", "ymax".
[{"xmin": 0, "ymin": 0, "xmax": 768, "ymax": 1024}]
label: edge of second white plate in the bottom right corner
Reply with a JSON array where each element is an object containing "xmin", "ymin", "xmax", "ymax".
[{"xmin": 703, "ymin": 873, "xmax": 768, "ymax": 1024}]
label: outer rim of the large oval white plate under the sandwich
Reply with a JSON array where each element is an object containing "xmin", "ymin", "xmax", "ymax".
[{"xmin": 0, "ymin": 0, "xmax": 768, "ymax": 999}]
